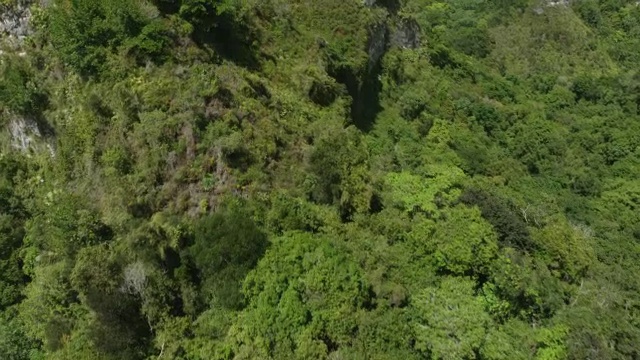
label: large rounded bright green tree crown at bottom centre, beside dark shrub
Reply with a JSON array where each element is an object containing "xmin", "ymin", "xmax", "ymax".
[{"xmin": 230, "ymin": 233, "xmax": 370, "ymax": 359}]
